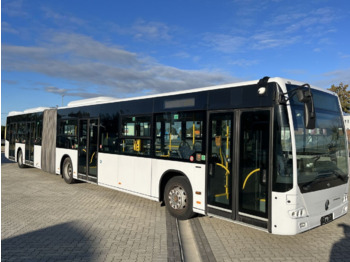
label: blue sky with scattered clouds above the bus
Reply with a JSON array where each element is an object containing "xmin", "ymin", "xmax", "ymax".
[{"xmin": 1, "ymin": 0, "xmax": 350, "ymax": 124}]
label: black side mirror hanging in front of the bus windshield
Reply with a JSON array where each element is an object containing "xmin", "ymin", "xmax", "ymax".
[{"xmin": 297, "ymin": 89, "xmax": 316, "ymax": 129}]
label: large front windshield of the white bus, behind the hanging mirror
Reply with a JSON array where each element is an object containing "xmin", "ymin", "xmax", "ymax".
[{"xmin": 287, "ymin": 85, "xmax": 348, "ymax": 193}]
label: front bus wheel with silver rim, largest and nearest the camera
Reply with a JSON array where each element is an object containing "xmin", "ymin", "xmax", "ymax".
[{"xmin": 164, "ymin": 176, "xmax": 194, "ymax": 220}]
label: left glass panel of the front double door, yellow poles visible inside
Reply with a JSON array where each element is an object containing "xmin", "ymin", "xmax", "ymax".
[{"xmin": 208, "ymin": 113, "xmax": 233, "ymax": 209}]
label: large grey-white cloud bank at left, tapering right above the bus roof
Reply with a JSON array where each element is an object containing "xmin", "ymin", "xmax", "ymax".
[{"xmin": 2, "ymin": 33, "xmax": 237, "ymax": 97}]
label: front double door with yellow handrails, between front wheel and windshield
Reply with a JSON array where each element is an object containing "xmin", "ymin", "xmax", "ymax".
[{"xmin": 207, "ymin": 109, "xmax": 271, "ymax": 228}]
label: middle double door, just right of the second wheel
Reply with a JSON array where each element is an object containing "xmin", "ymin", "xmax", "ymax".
[{"xmin": 78, "ymin": 119, "xmax": 99, "ymax": 183}]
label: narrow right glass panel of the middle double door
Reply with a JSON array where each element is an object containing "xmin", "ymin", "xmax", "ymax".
[{"xmin": 88, "ymin": 119, "xmax": 98, "ymax": 177}]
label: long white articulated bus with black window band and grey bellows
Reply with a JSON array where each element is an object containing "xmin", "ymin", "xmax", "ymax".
[{"xmin": 5, "ymin": 77, "xmax": 349, "ymax": 235}]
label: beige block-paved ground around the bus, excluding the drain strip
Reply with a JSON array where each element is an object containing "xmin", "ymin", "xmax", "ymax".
[{"xmin": 1, "ymin": 156, "xmax": 350, "ymax": 261}]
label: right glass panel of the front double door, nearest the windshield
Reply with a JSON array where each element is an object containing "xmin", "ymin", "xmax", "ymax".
[{"xmin": 239, "ymin": 110, "xmax": 270, "ymax": 217}]
